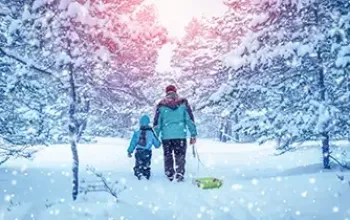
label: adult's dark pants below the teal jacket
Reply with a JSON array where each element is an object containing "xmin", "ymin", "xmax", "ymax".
[{"xmin": 163, "ymin": 139, "xmax": 187, "ymax": 180}]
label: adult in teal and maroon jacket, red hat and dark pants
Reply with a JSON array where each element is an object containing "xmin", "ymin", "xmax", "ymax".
[{"xmin": 153, "ymin": 85, "xmax": 197, "ymax": 182}]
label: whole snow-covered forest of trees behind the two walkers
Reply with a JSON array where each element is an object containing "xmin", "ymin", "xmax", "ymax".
[{"xmin": 0, "ymin": 0, "xmax": 350, "ymax": 180}]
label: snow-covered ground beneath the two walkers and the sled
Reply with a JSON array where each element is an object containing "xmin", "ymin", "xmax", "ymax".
[{"xmin": 0, "ymin": 139, "xmax": 350, "ymax": 220}]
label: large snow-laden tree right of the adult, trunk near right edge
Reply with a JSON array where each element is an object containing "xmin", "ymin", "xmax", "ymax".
[{"xmin": 207, "ymin": 1, "xmax": 349, "ymax": 168}]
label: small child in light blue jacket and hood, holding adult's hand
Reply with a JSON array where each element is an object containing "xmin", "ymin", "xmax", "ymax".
[{"xmin": 128, "ymin": 115, "xmax": 161, "ymax": 180}]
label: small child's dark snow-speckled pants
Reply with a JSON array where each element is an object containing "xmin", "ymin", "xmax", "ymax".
[{"xmin": 134, "ymin": 149, "xmax": 152, "ymax": 178}]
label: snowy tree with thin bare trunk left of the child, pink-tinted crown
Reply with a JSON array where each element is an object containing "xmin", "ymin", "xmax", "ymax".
[{"xmin": 0, "ymin": 0, "xmax": 166, "ymax": 199}]
